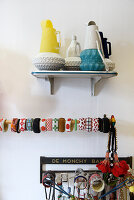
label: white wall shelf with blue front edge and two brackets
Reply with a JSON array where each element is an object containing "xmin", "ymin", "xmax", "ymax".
[{"xmin": 31, "ymin": 71, "xmax": 118, "ymax": 96}]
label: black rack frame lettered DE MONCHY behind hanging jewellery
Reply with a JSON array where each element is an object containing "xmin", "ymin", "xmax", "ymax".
[{"xmin": 40, "ymin": 156, "xmax": 132, "ymax": 183}]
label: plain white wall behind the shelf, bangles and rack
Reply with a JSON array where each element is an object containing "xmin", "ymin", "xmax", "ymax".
[{"xmin": 0, "ymin": 0, "xmax": 134, "ymax": 200}]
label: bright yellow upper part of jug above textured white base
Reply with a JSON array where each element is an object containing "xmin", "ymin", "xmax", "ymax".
[{"xmin": 40, "ymin": 20, "xmax": 60, "ymax": 53}]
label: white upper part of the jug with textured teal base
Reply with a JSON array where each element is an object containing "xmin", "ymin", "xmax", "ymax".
[{"xmin": 84, "ymin": 21, "xmax": 102, "ymax": 50}]
